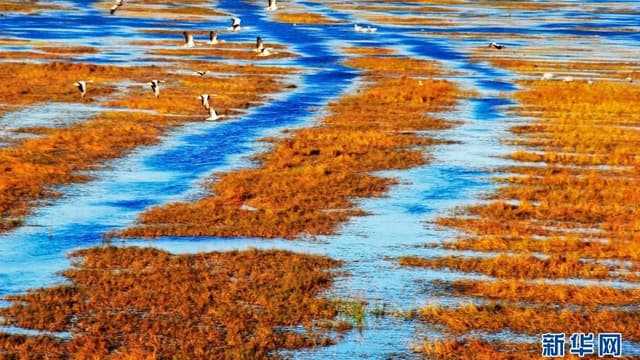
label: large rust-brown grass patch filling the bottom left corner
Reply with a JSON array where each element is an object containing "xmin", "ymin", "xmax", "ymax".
[{"xmin": 0, "ymin": 247, "xmax": 340, "ymax": 359}]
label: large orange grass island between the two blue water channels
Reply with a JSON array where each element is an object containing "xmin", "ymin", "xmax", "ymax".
[{"xmin": 117, "ymin": 58, "xmax": 456, "ymax": 238}]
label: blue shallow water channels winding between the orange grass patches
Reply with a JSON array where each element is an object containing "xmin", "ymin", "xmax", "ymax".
[{"xmin": 0, "ymin": 0, "xmax": 640, "ymax": 359}]
